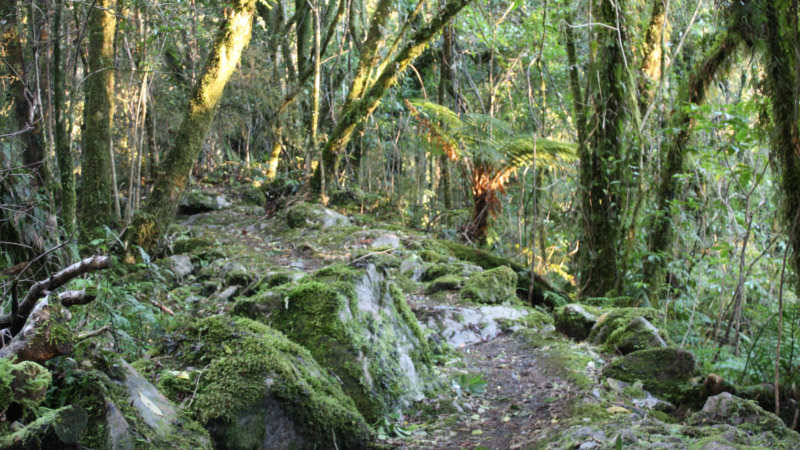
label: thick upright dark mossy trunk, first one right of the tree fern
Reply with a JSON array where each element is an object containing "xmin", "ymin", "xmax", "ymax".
[{"xmin": 579, "ymin": 0, "xmax": 627, "ymax": 297}]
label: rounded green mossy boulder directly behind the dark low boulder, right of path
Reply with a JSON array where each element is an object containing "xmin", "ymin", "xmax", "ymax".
[{"xmin": 589, "ymin": 308, "xmax": 669, "ymax": 354}]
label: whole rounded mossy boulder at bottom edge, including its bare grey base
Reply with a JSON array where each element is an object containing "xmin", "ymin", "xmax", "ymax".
[{"xmin": 159, "ymin": 316, "xmax": 371, "ymax": 449}]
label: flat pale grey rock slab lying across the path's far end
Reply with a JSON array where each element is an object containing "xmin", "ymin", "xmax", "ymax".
[{"xmin": 422, "ymin": 305, "xmax": 529, "ymax": 348}]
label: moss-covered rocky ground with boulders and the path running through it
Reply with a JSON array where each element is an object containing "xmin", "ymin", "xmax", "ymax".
[{"xmin": 0, "ymin": 185, "xmax": 800, "ymax": 449}]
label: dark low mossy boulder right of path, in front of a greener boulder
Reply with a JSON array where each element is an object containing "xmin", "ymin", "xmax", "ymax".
[{"xmin": 603, "ymin": 348, "xmax": 702, "ymax": 405}]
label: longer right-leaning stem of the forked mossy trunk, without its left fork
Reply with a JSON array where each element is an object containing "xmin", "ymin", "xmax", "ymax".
[{"xmin": 311, "ymin": 0, "xmax": 470, "ymax": 191}]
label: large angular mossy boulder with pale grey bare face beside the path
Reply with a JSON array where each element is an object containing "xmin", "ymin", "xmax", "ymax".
[{"xmin": 237, "ymin": 264, "xmax": 432, "ymax": 421}]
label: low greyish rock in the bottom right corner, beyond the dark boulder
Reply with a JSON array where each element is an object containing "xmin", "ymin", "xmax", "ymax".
[{"xmin": 689, "ymin": 392, "xmax": 794, "ymax": 436}]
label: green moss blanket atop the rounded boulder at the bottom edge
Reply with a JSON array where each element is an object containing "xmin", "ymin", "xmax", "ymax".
[{"xmin": 167, "ymin": 316, "xmax": 371, "ymax": 448}]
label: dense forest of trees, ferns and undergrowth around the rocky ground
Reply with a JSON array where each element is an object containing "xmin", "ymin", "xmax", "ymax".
[{"xmin": 0, "ymin": 0, "xmax": 800, "ymax": 445}]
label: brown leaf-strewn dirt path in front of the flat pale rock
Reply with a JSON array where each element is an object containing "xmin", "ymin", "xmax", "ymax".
[{"xmin": 385, "ymin": 333, "xmax": 577, "ymax": 449}]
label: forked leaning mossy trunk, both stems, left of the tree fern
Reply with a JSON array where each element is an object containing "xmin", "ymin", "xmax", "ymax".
[{"xmin": 311, "ymin": 0, "xmax": 470, "ymax": 192}]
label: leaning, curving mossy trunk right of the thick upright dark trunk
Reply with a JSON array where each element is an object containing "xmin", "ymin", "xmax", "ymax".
[{"xmin": 644, "ymin": 31, "xmax": 742, "ymax": 297}]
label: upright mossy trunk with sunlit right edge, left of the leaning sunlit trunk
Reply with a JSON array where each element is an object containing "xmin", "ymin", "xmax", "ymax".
[{"xmin": 78, "ymin": 0, "xmax": 117, "ymax": 234}]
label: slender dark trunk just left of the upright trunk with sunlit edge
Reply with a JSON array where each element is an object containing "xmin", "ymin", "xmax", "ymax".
[{"xmin": 52, "ymin": 0, "xmax": 76, "ymax": 236}]
